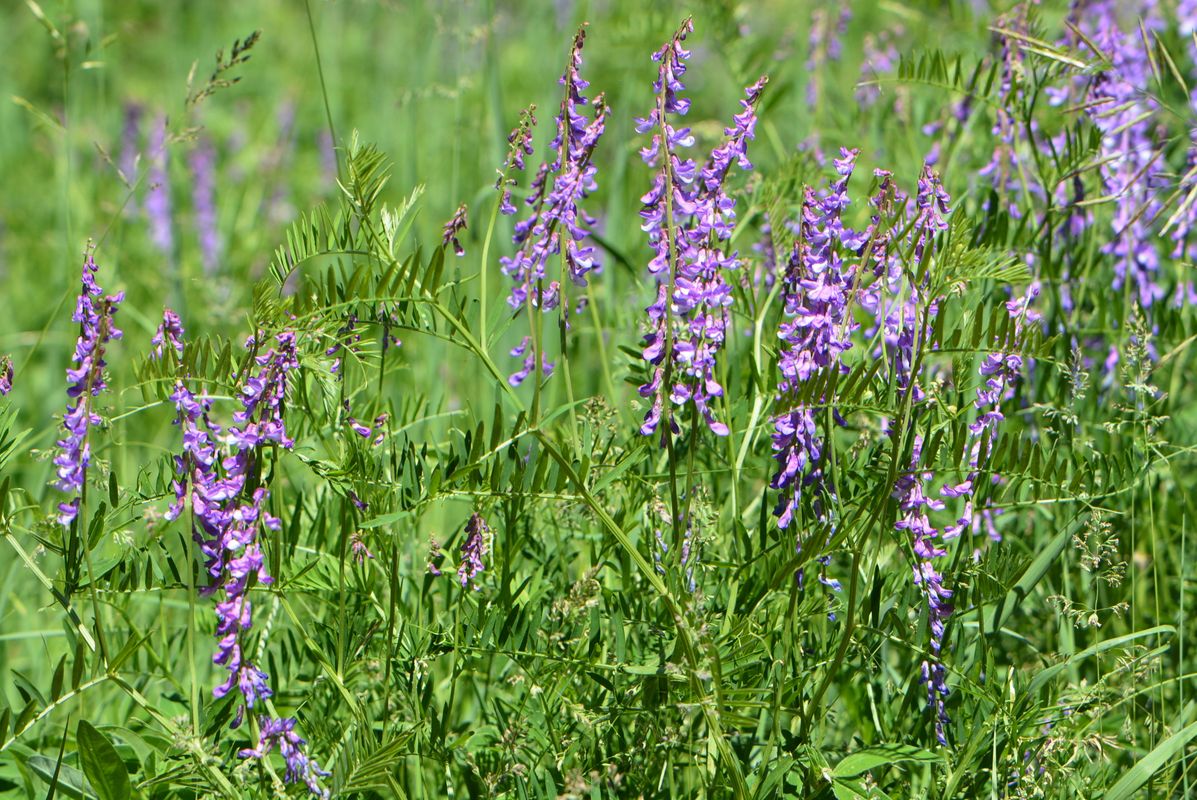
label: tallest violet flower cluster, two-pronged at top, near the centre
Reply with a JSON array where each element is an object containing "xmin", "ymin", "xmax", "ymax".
[{"xmin": 636, "ymin": 19, "xmax": 767, "ymax": 446}]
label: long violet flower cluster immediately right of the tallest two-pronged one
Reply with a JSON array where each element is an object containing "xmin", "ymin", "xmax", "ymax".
[{"xmin": 770, "ymin": 150, "xmax": 862, "ymax": 536}]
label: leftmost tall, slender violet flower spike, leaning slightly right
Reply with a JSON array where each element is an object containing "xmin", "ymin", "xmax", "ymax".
[{"xmin": 54, "ymin": 248, "xmax": 124, "ymax": 526}]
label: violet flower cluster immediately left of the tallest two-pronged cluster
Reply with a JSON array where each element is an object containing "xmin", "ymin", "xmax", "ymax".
[{"xmin": 500, "ymin": 28, "xmax": 608, "ymax": 386}]
